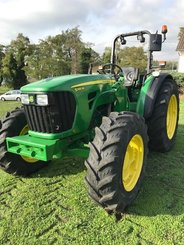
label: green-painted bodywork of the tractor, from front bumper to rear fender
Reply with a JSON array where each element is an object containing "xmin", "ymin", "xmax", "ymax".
[{"xmin": 6, "ymin": 74, "xmax": 153, "ymax": 161}]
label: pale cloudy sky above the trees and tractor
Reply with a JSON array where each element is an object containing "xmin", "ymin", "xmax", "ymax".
[{"xmin": 0, "ymin": 0, "xmax": 184, "ymax": 60}]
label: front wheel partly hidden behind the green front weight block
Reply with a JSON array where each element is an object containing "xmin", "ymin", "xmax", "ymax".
[{"xmin": 0, "ymin": 108, "xmax": 47, "ymax": 176}]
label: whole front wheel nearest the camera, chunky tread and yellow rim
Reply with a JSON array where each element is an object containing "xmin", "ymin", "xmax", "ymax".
[{"xmin": 85, "ymin": 112, "xmax": 148, "ymax": 214}]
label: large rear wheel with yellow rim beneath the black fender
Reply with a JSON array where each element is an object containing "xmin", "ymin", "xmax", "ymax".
[{"xmin": 147, "ymin": 79, "xmax": 179, "ymax": 152}]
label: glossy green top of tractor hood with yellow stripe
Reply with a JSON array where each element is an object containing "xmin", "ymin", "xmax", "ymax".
[{"xmin": 21, "ymin": 74, "xmax": 115, "ymax": 93}]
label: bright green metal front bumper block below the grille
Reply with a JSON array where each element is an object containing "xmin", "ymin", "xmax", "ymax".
[{"xmin": 6, "ymin": 135, "xmax": 89, "ymax": 164}]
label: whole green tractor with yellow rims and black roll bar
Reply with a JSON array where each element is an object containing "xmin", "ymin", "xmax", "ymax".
[{"xmin": 0, "ymin": 26, "xmax": 179, "ymax": 214}]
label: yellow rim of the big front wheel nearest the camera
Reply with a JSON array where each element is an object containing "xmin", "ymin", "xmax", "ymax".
[{"xmin": 122, "ymin": 134, "xmax": 144, "ymax": 191}]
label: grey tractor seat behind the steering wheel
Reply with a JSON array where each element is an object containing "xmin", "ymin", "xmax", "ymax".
[{"xmin": 122, "ymin": 67, "xmax": 139, "ymax": 87}]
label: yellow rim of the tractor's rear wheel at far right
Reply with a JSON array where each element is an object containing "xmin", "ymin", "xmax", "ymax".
[{"xmin": 166, "ymin": 94, "xmax": 178, "ymax": 139}]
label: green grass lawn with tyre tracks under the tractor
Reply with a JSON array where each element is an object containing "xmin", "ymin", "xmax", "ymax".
[{"xmin": 0, "ymin": 101, "xmax": 184, "ymax": 245}]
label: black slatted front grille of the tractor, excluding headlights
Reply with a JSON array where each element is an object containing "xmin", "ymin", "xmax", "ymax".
[{"xmin": 24, "ymin": 91, "xmax": 76, "ymax": 133}]
